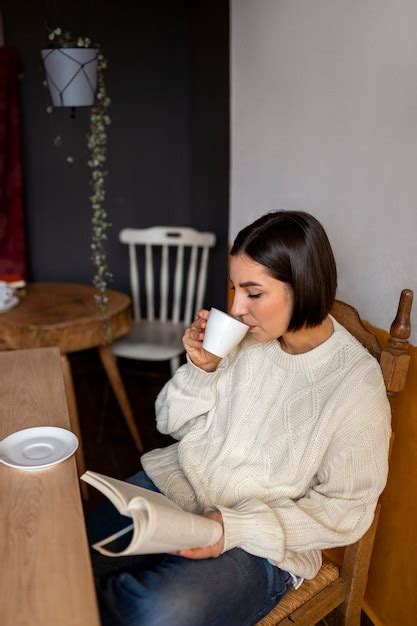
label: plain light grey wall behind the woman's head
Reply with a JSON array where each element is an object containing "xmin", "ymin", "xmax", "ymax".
[{"xmin": 229, "ymin": 0, "xmax": 417, "ymax": 344}]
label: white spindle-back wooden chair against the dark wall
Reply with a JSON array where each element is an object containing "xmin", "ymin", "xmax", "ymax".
[{"xmin": 112, "ymin": 226, "xmax": 216, "ymax": 374}]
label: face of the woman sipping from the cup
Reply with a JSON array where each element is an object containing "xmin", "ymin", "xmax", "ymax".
[{"xmin": 230, "ymin": 254, "xmax": 292, "ymax": 342}]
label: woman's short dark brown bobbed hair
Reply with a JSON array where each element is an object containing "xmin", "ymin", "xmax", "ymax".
[{"xmin": 230, "ymin": 211, "xmax": 337, "ymax": 331}]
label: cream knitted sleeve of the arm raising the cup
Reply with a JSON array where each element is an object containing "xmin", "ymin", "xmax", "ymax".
[{"xmin": 155, "ymin": 357, "xmax": 226, "ymax": 439}]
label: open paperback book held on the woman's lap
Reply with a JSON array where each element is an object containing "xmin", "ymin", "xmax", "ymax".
[{"xmin": 81, "ymin": 471, "xmax": 223, "ymax": 556}]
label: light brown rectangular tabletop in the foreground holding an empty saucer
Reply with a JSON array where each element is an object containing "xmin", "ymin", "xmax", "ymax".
[{"xmin": 0, "ymin": 348, "xmax": 100, "ymax": 626}]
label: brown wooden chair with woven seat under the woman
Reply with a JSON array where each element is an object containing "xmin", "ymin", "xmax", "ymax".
[{"xmin": 258, "ymin": 289, "xmax": 413, "ymax": 626}]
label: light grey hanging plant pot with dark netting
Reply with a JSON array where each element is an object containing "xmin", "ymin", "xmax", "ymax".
[{"xmin": 41, "ymin": 44, "xmax": 97, "ymax": 107}]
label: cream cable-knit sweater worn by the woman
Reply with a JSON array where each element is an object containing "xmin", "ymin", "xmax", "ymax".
[{"xmin": 142, "ymin": 318, "xmax": 390, "ymax": 578}]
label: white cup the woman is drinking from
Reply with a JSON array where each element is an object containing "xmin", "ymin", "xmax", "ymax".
[{"xmin": 203, "ymin": 307, "xmax": 250, "ymax": 358}]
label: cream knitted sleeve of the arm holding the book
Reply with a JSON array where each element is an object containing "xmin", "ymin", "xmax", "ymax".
[{"xmin": 216, "ymin": 380, "xmax": 391, "ymax": 573}]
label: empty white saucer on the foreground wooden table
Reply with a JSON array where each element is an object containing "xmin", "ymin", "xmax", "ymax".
[{"xmin": 0, "ymin": 426, "xmax": 78, "ymax": 470}]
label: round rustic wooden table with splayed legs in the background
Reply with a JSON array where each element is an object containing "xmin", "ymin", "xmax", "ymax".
[{"xmin": 0, "ymin": 283, "xmax": 143, "ymax": 488}]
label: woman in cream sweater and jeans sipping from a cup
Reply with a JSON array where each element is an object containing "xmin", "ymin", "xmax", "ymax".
[{"xmin": 88, "ymin": 211, "xmax": 390, "ymax": 626}]
